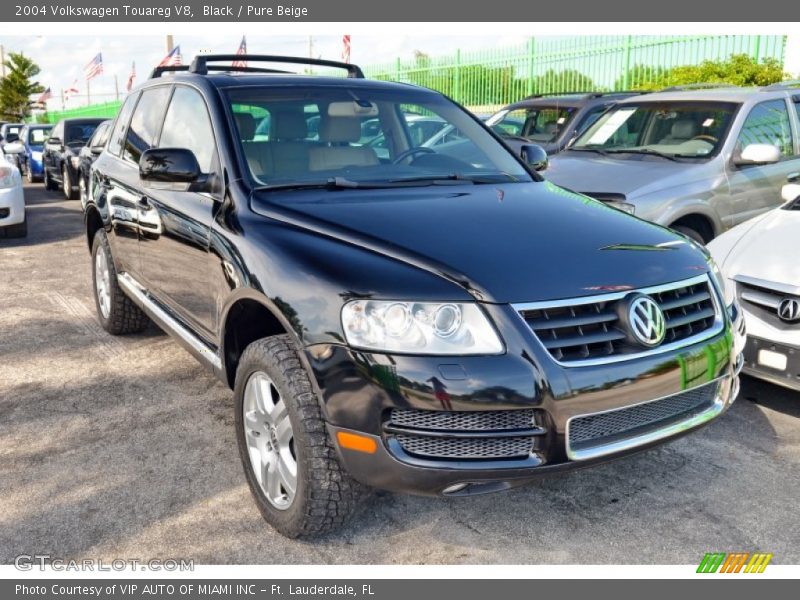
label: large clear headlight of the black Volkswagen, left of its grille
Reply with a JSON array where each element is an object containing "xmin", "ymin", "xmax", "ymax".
[{"xmin": 342, "ymin": 300, "xmax": 503, "ymax": 355}]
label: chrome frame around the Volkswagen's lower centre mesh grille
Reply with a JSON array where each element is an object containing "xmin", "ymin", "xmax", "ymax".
[{"xmin": 565, "ymin": 377, "xmax": 738, "ymax": 460}]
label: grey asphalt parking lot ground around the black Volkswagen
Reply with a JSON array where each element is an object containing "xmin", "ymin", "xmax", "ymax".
[{"xmin": 0, "ymin": 185, "xmax": 800, "ymax": 564}]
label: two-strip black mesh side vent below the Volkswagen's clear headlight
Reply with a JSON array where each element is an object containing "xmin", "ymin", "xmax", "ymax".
[{"xmin": 384, "ymin": 408, "xmax": 544, "ymax": 461}]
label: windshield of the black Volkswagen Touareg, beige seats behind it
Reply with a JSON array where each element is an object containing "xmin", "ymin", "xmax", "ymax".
[{"xmin": 228, "ymin": 86, "xmax": 531, "ymax": 187}]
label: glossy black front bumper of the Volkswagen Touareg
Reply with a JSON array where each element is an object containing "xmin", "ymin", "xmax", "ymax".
[{"xmin": 306, "ymin": 306, "xmax": 743, "ymax": 495}]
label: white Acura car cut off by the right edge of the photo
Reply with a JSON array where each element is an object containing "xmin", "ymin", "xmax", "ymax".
[{"xmin": 708, "ymin": 183, "xmax": 800, "ymax": 391}]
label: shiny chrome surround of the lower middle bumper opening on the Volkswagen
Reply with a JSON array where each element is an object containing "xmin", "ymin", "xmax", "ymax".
[{"xmin": 564, "ymin": 375, "xmax": 736, "ymax": 460}]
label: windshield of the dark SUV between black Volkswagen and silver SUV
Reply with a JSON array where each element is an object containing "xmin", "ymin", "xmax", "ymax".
[{"xmin": 486, "ymin": 105, "xmax": 578, "ymax": 144}]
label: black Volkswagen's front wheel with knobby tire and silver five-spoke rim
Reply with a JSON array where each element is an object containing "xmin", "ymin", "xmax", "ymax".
[{"xmin": 234, "ymin": 335, "xmax": 365, "ymax": 538}]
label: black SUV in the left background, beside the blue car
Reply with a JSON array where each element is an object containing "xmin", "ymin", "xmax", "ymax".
[{"xmin": 42, "ymin": 118, "xmax": 105, "ymax": 200}]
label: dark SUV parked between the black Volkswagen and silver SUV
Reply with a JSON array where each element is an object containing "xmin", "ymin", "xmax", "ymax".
[{"xmin": 486, "ymin": 92, "xmax": 641, "ymax": 155}]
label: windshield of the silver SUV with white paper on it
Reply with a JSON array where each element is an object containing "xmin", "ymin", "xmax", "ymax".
[{"xmin": 571, "ymin": 102, "xmax": 737, "ymax": 158}]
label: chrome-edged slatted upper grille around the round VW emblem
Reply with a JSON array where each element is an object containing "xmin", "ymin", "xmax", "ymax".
[{"xmin": 520, "ymin": 277, "xmax": 717, "ymax": 363}]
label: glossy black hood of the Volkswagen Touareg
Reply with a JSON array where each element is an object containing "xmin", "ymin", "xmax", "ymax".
[{"xmin": 252, "ymin": 182, "xmax": 706, "ymax": 303}]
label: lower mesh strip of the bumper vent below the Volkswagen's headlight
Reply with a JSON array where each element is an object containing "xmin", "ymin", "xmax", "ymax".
[{"xmin": 397, "ymin": 435, "xmax": 533, "ymax": 460}]
